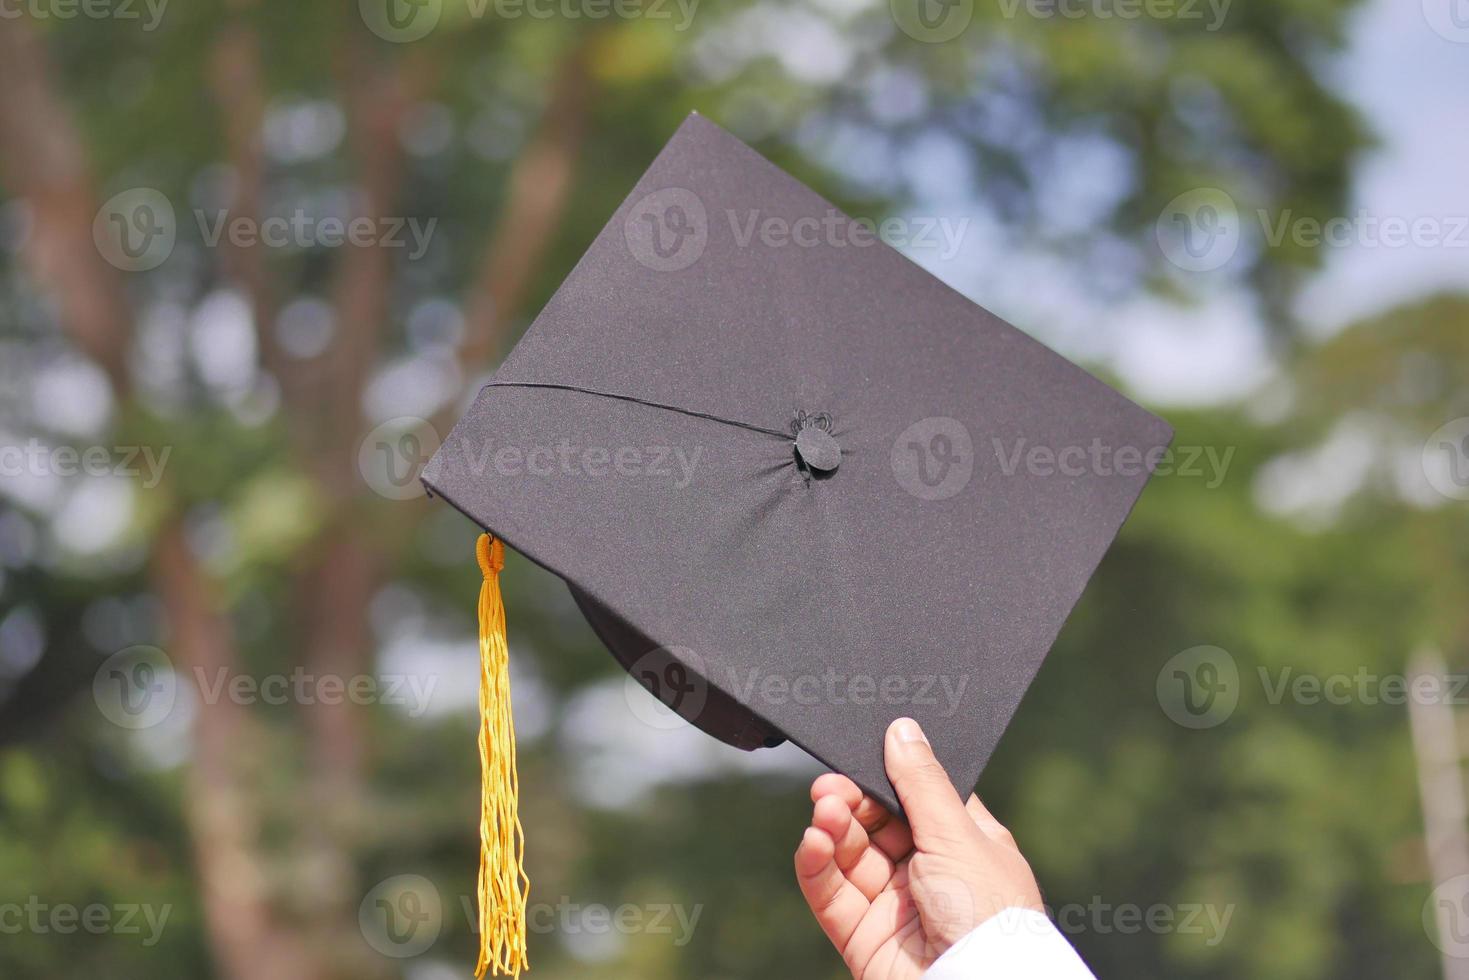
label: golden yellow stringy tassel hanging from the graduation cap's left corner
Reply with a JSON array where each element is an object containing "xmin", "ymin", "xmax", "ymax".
[{"xmin": 474, "ymin": 535, "xmax": 530, "ymax": 977}]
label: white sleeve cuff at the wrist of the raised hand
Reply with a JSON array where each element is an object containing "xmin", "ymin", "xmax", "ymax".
[{"xmin": 923, "ymin": 908, "xmax": 1096, "ymax": 980}]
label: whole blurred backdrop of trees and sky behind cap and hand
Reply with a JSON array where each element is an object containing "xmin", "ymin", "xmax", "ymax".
[{"xmin": 0, "ymin": 0, "xmax": 1469, "ymax": 980}]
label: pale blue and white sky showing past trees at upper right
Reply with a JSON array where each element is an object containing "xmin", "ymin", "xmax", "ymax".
[{"xmin": 881, "ymin": 0, "xmax": 1469, "ymax": 408}]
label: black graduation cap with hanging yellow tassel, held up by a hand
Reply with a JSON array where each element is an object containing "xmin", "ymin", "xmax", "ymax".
[{"xmin": 423, "ymin": 116, "xmax": 1171, "ymax": 973}]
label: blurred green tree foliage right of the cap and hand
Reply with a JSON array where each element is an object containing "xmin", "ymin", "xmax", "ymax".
[{"xmin": 983, "ymin": 297, "xmax": 1469, "ymax": 980}]
